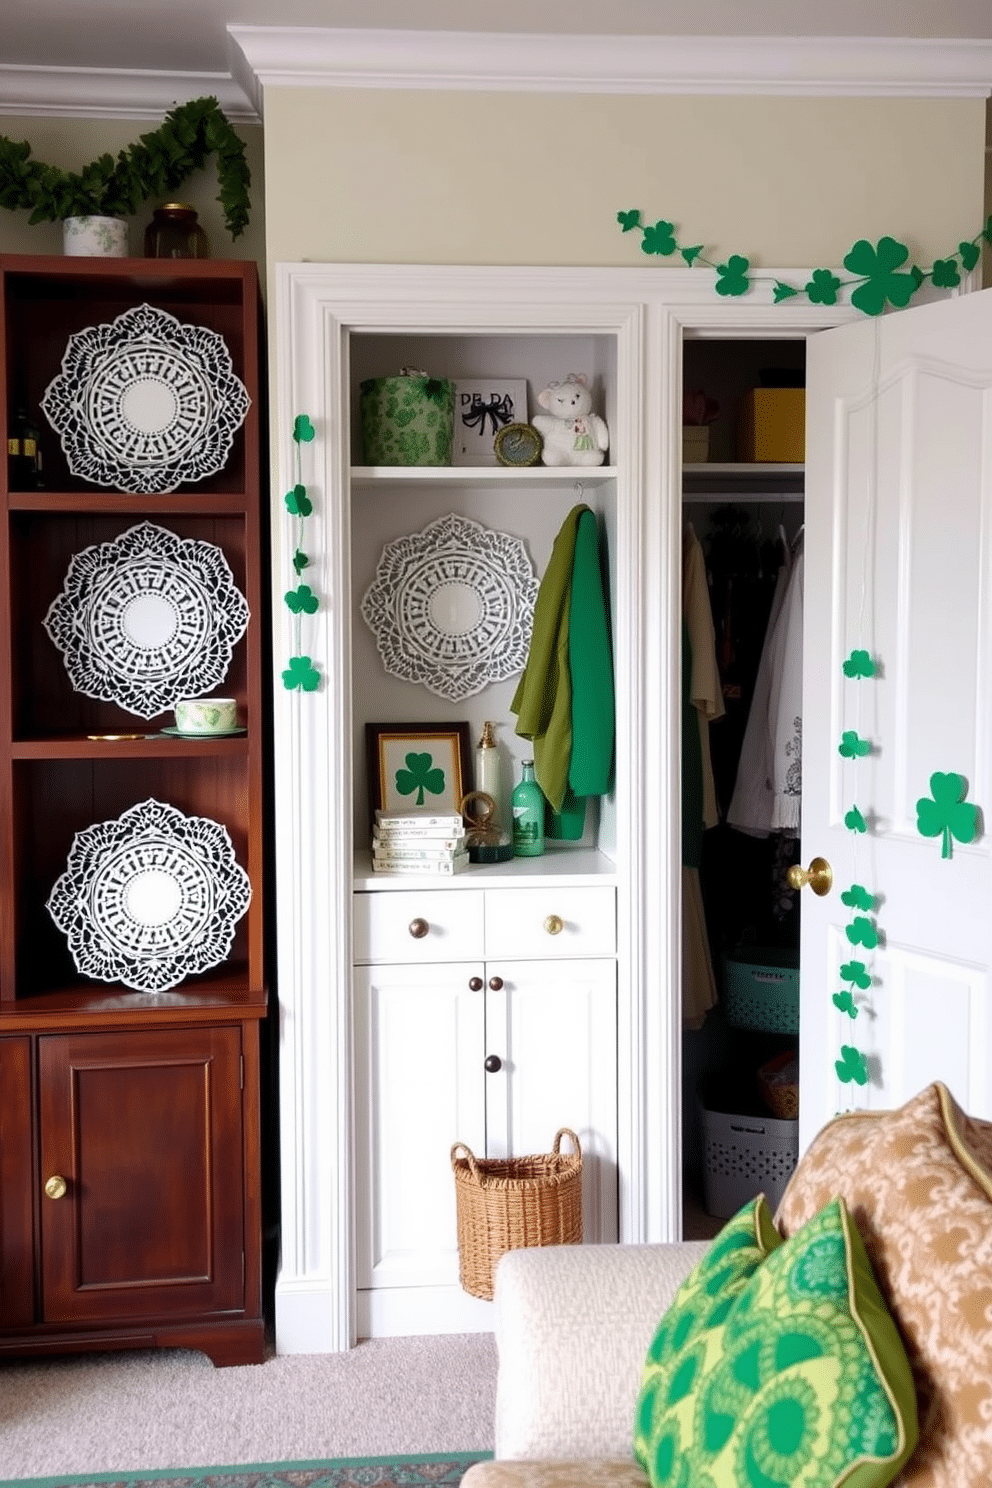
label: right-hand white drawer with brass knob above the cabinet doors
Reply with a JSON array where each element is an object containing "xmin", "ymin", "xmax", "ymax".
[{"xmin": 486, "ymin": 885, "xmax": 617, "ymax": 960}]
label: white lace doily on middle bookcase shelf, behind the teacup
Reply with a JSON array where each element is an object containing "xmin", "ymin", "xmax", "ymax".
[{"xmin": 43, "ymin": 522, "xmax": 248, "ymax": 719}]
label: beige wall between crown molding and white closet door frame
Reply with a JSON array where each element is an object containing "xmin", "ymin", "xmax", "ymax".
[{"xmin": 265, "ymin": 88, "xmax": 986, "ymax": 279}]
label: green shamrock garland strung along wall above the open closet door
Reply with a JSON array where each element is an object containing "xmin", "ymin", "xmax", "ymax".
[{"xmin": 617, "ymin": 208, "xmax": 992, "ymax": 315}]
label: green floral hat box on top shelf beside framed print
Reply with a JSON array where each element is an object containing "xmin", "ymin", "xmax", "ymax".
[{"xmin": 358, "ymin": 368, "xmax": 455, "ymax": 464}]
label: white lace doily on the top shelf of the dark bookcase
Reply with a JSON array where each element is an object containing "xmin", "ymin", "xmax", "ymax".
[{"xmin": 42, "ymin": 305, "xmax": 251, "ymax": 493}]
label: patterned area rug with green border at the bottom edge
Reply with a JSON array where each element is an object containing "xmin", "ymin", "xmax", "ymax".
[{"xmin": 0, "ymin": 1452, "xmax": 492, "ymax": 1488}]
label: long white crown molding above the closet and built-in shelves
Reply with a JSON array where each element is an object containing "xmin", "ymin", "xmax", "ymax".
[{"xmin": 228, "ymin": 25, "xmax": 992, "ymax": 113}]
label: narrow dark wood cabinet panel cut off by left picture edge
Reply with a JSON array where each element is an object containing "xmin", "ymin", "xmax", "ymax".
[{"xmin": 0, "ymin": 1037, "xmax": 34, "ymax": 1327}]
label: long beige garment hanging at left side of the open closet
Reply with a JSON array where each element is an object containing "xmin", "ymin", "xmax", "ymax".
[{"xmin": 683, "ymin": 522, "xmax": 724, "ymax": 1028}]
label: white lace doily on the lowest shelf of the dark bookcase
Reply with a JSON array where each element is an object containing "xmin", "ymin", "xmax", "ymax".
[{"xmin": 48, "ymin": 799, "xmax": 251, "ymax": 992}]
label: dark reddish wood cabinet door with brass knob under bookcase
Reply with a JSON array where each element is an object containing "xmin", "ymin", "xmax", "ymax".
[{"xmin": 39, "ymin": 1025, "xmax": 245, "ymax": 1324}]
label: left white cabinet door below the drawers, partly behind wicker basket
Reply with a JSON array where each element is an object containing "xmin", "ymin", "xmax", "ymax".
[{"xmin": 354, "ymin": 961, "xmax": 485, "ymax": 1291}]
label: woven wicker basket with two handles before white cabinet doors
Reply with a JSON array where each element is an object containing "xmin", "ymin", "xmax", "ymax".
[{"xmin": 451, "ymin": 1126, "xmax": 582, "ymax": 1299}]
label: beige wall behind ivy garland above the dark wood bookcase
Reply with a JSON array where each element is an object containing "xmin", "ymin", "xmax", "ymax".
[{"xmin": 0, "ymin": 116, "xmax": 265, "ymax": 270}]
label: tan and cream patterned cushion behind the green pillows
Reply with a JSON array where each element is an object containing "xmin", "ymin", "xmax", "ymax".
[{"xmin": 775, "ymin": 1083, "xmax": 992, "ymax": 1488}]
